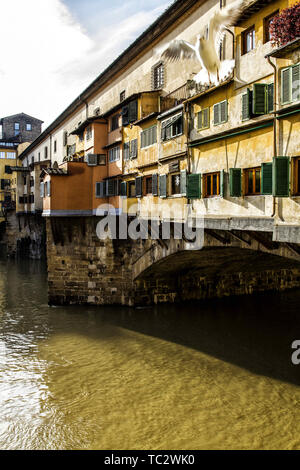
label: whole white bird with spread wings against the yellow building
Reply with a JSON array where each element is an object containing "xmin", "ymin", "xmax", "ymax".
[{"xmin": 157, "ymin": 0, "xmax": 251, "ymax": 86}]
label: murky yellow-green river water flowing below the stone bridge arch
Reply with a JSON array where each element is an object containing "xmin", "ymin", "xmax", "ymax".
[{"xmin": 0, "ymin": 259, "xmax": 300, "ymax": 450}]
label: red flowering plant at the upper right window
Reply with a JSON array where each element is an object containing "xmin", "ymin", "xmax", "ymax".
[{"xmin": 270, "ymin": 2, "xmax": 300, "ymax": 47}]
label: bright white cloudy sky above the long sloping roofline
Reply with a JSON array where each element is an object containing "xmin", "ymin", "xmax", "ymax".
[{"xmin": 0, "ymin": 0, "xmax": 173, "ymax": 129}]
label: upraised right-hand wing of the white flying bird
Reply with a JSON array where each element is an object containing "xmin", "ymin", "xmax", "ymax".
[{"xmin": 208, "ymin": 0, "xmax": 250, "ymax": 50}]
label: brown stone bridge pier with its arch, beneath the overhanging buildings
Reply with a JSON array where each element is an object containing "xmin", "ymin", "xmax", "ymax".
[{"xmin": 46, "ymin": 217, "xmax": 300, "ymax": 306}]
